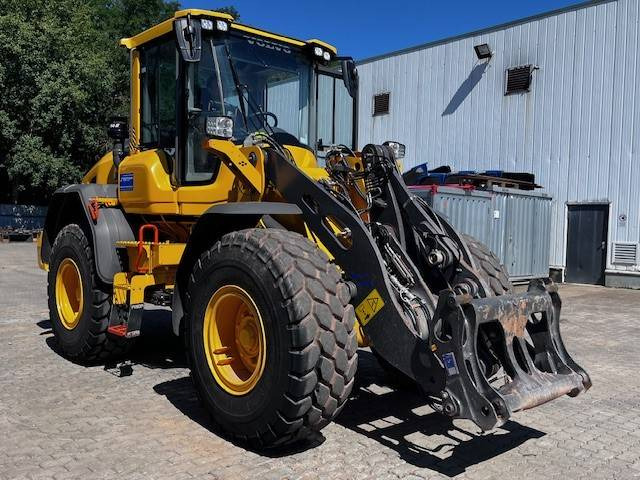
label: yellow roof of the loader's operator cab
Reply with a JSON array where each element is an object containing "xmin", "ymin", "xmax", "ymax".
[{"xmin": 120, "ymin": 8, "xmax": 338, "ymax": 55}]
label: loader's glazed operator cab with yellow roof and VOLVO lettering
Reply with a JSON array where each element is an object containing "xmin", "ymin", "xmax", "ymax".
[{"xmin": 117, "ymin": 10, "xmax": 357, "ymax": 186}]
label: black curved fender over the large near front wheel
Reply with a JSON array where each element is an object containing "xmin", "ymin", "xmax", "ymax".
[{"xmin": 171, "ymin": 202, "xmax": 302, "ymax": 335}]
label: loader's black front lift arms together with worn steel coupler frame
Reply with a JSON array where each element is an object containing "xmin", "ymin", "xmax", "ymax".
[{"xmin": 265, "ymin": 145, "xmax": 591, "ymax": 430}]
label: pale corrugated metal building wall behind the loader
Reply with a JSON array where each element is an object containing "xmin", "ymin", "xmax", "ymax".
[{"xmin": 358, "ymin": 0, "xmax": 640, "ymax": 286}]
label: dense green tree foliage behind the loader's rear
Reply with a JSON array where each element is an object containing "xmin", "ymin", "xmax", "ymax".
[{"xmin": 0, "ymin": 0, "xmax": 178, "ymax": 202}]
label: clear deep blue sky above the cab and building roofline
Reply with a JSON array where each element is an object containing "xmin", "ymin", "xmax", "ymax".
[{"xmin": 182, "ymin": 0, "xmax": 592, "ymax": 59}]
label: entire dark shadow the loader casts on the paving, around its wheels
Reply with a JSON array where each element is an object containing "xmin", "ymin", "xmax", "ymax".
[{"xmin": 37, "ymin": 309, "xmax": 545, "ymax": 476}]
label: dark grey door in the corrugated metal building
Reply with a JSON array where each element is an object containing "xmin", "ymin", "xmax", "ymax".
[{"xmin": 565, "ymin": 204, "xmax": 609, "ymax": 285}]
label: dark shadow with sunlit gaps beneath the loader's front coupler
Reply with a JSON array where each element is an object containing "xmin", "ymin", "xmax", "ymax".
[{"xmin": 336, "ymin": 351, "xmax": 545, "ymax": 476}]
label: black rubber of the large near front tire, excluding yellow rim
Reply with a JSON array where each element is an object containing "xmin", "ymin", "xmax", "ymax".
[{"xmin": 185, "ymin": 229, "xmax": 357, "ymax": 448}]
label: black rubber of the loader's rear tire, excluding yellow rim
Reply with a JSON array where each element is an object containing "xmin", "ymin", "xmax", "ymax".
[{"xmin": 47, "ymin": 224, "xmax": 132, "ymax": 362}]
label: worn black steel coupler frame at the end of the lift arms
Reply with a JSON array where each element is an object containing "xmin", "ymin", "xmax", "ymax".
[{"xmin": 431, "ymin": 280, "xmax": 591, "ymax": 430}]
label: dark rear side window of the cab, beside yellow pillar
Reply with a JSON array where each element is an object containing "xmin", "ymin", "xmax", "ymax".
[{"xmin": 140, "ymin": 40, "xmax": 177, "ymax": 148}]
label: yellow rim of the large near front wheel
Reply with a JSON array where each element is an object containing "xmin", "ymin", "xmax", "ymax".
[{"xmin": 203, "ymin": 285, "xmax": 266, "ymax": 395}]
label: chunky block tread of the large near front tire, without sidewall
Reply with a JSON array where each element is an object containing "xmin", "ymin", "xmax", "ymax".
[{"xmin": 185, "ymin": 229, "xmax": 357, "ymax": 446}]
